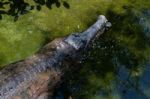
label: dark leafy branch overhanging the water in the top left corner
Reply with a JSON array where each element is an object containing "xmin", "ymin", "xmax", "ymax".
[{"xmin": 0, "ymin": 0, "xmax": 70, "ymax": 21}]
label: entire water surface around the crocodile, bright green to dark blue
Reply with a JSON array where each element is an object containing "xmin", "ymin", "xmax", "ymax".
[{"xmin": 0, "ymin": 0, "xmax": 150, "ymax": 99}]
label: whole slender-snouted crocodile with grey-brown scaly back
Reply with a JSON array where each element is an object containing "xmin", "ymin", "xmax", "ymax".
[{"xmin": 0, "ymin": 15, "xmax": 111, "ymax": 99}]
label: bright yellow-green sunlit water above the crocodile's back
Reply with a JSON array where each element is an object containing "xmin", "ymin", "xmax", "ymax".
[{"xmin": 0, "ymin": 0, "xmax": 149, "ymax": 65}]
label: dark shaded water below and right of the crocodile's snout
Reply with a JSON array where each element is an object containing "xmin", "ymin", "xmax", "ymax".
[{"xmin": 54, "ymin": 6, "xmax": 150, "ymax": 99}]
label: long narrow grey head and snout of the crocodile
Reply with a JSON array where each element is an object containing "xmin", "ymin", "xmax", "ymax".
[{"xmin": 65, "ymin": 15, "xmax": 111, "ymax": 50}]
